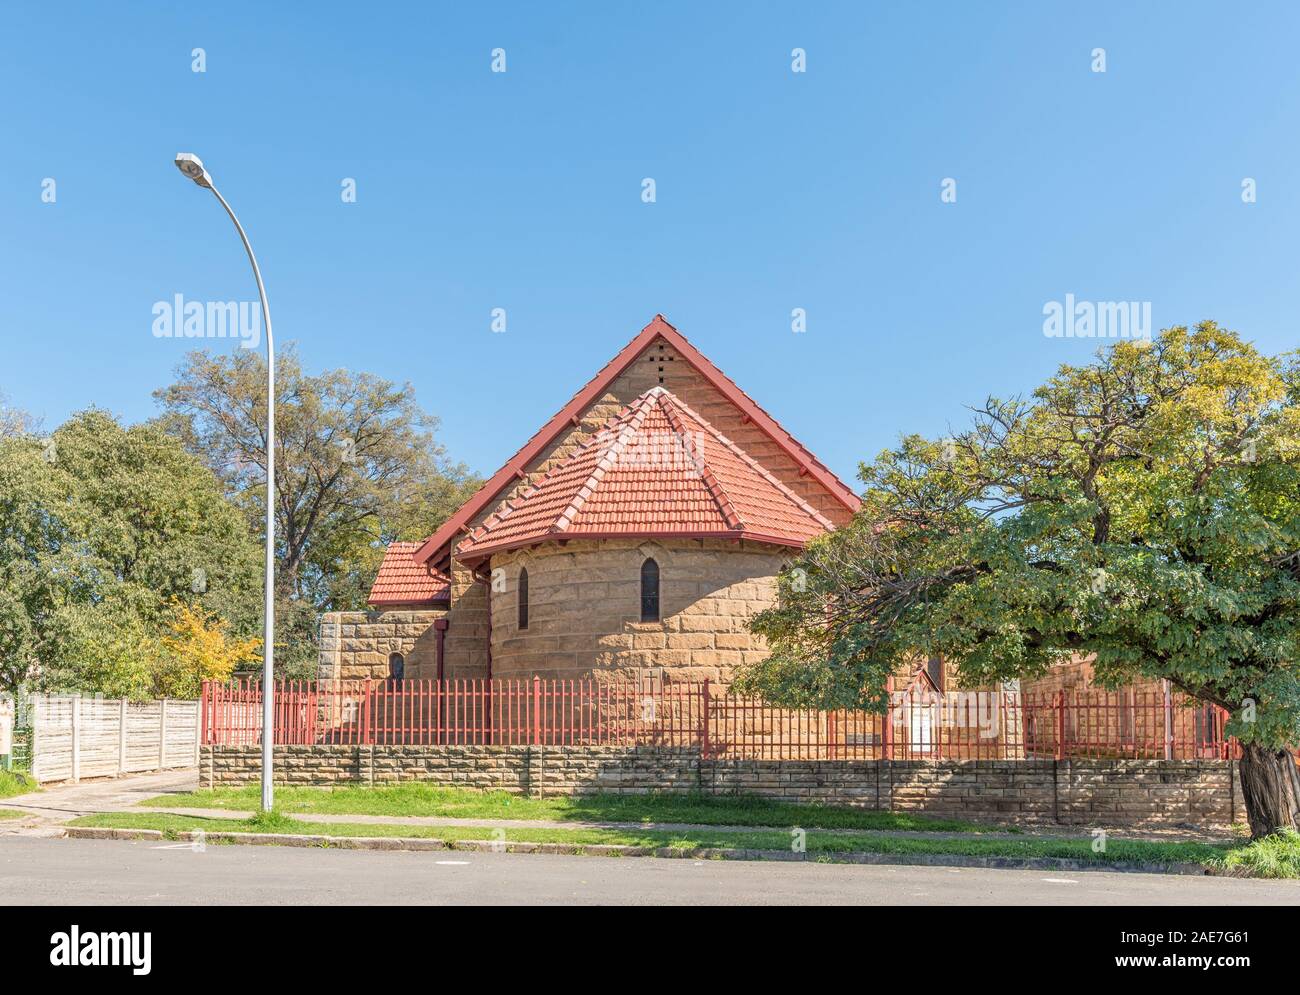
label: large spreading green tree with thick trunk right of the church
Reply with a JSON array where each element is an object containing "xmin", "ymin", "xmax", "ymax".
[{"xmin": 741, "ymin": 323, "xmax": 1300, "ymax": 835}]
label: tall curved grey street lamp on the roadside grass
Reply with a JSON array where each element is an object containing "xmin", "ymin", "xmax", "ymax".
[{"xmin": 176, "ymin": 152, "xmax": 276, "ymax": 812}]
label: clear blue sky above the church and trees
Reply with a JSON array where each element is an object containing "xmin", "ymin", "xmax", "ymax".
[{"xmin": 0, "ymin": 3, "xmax": 1300, "ymax": 489}]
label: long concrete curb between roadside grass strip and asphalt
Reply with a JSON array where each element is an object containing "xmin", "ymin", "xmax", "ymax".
[{"xmin": 55, "ymin": 826, "xmax": 1222, "ymax": 877}]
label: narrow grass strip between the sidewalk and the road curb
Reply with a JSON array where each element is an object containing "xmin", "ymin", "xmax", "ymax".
[{"xmin": 70, "ymin": 813, "xmax": 1258, "ymax": 869}]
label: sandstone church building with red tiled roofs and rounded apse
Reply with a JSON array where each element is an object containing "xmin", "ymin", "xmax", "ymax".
[{"xmin": 319, "ymin": 315, "xmax": 858, "ymax": 684}]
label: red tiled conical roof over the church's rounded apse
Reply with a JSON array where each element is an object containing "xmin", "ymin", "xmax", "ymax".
[{"xmin": 456, "ymin": 386, "xmax": 835, "ymax": 563}]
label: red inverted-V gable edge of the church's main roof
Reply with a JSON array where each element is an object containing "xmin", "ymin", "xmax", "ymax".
[{"xmin": 415, "ymin": 315, "xmax": 861, "ymax": 562}]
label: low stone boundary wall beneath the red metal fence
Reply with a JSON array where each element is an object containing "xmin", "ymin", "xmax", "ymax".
[{"xmin": 199, "ymin": 745, "xmax": 1244, "ymax": 827}]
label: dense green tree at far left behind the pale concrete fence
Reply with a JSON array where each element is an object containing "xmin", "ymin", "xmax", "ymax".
[{"xmin": 0, "ymin": 410, "xmax": 260, "ymax": 697}]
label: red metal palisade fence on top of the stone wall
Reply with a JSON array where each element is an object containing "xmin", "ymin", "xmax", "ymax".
[{"xmin": 200, "ymin": 679, "xmax": 1239, "ymax": 761}]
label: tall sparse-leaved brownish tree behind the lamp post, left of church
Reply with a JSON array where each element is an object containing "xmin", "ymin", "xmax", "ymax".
[{"xmin": 155, "ymin": 349, "xmax": 478, "ymax": 609}]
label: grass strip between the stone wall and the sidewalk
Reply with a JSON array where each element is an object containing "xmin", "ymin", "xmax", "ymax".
[{"xmin": 140, "ymin": 783, "xmax": 1017, "ymax": 832}]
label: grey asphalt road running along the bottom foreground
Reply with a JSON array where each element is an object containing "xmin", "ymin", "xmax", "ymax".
[{"xmin": 0, "ymin": 836, "xmax": 1300, "ymax": 905}]
